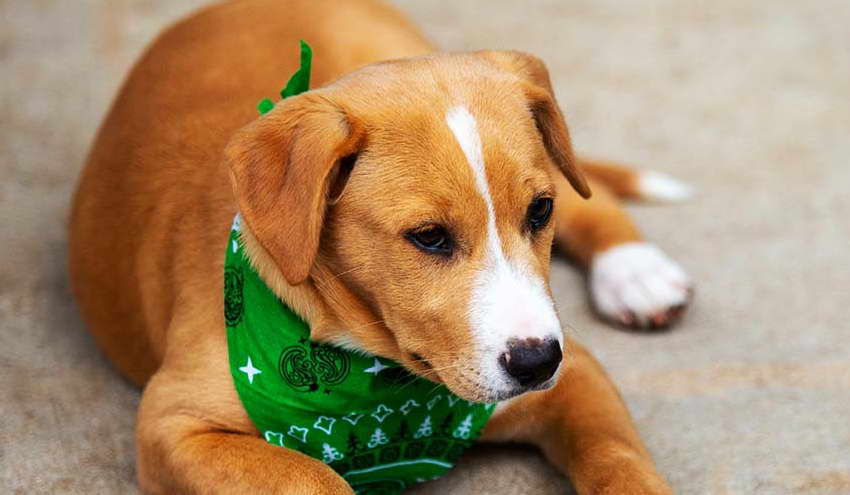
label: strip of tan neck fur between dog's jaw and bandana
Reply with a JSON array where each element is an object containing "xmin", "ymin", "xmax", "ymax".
[{"xmin": 235, "ymin": 224, "xmax": 401, "ymax": 361}]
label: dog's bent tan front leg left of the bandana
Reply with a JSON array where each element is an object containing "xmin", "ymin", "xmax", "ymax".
[{"xmin": 136, "ymin": 372, "xmax": 354, "ymax": 495}]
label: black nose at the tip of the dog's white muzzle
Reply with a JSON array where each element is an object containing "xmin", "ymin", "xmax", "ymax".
[{"xmin": 499, "ymin": 339, "xmax": 561, "ymax": 387}]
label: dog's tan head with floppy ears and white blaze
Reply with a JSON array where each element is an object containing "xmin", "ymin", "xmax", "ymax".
[{"xmin": 227, "ymin": 52, "xmax": 589, "ymax": 401}]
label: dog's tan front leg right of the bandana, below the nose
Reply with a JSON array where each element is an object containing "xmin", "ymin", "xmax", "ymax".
[{"xmin": 482, "ymin": 340, "xmax": 672, "ymax": 495}]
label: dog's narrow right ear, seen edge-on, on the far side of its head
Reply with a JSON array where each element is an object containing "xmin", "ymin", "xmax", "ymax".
[{"xmin": 479, "ymin": 50, "xmax": 591, "ymax": 198}]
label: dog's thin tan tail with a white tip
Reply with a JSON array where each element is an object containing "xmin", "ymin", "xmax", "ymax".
[{"xmin": 578, "ymin": 158, "xmax": 694, "ymax": 202}]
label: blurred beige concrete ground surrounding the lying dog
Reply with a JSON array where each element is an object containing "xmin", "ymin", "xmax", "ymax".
[{"xmin": 0, "ymin": 0, "xmax": 850, "ymax": 495}]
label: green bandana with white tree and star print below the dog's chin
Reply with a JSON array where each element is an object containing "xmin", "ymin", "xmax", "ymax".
[{"xmin": 224, "ymin": 219, "xmax": 495, "ymax": 495}]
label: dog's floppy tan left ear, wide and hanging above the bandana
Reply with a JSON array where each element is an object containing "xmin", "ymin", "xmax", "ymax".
[{"xmin": 225, "ymin": 92, "xmax": 365, "ymax": 285}]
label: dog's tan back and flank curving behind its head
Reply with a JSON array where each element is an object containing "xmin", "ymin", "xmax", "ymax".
[{"xmin": 70, "ymin": 0, "xmax": 432, "ymax": 384}]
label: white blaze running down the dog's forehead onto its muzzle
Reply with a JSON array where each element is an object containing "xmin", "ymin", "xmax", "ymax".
[{"xmin": 446, "ymin": 106, "xmax": 563, "ymax": 385}]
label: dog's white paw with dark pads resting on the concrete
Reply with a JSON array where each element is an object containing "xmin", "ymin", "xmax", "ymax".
[{"xmin": 590, "ymin": 242, "xmax": 693, "ymax": 328}]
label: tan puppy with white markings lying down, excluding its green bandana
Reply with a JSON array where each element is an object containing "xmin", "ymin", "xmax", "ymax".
[{"xmin": 69, "ymin": 0, "xmax": 691, "ymax": 494}]
